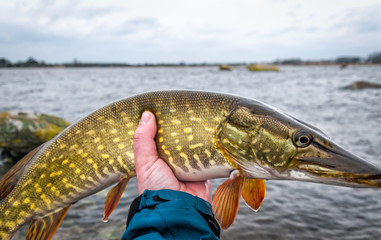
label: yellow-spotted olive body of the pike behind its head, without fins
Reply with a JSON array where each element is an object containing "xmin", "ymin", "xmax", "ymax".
[{"xmin": 0, "ymin": 91, "xmax": 238, "ymax": 239}]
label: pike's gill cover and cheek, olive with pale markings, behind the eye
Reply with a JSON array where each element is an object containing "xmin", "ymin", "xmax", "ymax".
[{"xmin": 216, "ymin": 107, "xmax": 297, "ymax": 179}]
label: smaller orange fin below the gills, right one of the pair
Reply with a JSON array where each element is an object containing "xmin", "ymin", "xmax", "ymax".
[{"xmin": 241, "ymin": 179, "xmax": 266, "ymax": 211}]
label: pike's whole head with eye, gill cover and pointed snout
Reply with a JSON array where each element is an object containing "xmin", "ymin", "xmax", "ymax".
[{"xmin": 215, "ymin": 101, "xmax": 381, "ymax": 187}]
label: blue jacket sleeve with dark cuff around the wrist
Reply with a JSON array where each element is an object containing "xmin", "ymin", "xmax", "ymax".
[{"xmin": 122, "ymin": 189, "xmax": 220, "ymax": 240}]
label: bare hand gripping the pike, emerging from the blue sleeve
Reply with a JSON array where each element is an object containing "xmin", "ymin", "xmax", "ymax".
[{"xmin": 134, "ymin": 111, "xmax": 212, "ymax": 202}]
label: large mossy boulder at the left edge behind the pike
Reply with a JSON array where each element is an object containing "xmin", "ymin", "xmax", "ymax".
[{"xmin": 0, "ymin": 112, "xmax": 70, "ymax": 160}]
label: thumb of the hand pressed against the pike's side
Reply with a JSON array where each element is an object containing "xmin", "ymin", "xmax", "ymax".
[{"xmin": 134, "ymin": 111, "xmax": 158, "ymax": 177}]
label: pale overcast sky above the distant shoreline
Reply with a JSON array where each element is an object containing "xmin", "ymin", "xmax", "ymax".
[{"xmin": 0, "ymin": 0, "xmax": 381, "ymax": 63}]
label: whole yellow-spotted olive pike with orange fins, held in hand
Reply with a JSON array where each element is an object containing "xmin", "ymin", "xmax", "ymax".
[{"xmin": 0, "ymin": 91, "xmax": 381, "ymax": 240}]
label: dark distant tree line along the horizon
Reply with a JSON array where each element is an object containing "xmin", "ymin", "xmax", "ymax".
[{"xmin": 0, "ymin": 52, "xmax": 381, "ymax": 68}]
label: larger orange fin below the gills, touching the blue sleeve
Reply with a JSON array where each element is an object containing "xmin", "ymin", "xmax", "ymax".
[{"xmin": 212, "ymin": 172, "xmax": 244, "ymax": 229}]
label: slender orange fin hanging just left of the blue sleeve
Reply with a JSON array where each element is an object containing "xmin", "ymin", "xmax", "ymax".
[{"xmin": 103, "ymin": 177, "xmax": 130, "ymax": 222}]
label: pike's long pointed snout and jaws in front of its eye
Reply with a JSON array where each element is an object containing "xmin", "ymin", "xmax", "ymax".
[{"xmin": 289, "ymin": 143, "xmax": 381, "ymax": 188}]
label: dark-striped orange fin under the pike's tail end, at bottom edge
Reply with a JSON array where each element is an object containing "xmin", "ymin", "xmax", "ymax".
[{"xmin": 26, "ymin": 205, "xmax": 71, "ymax": 240}]
